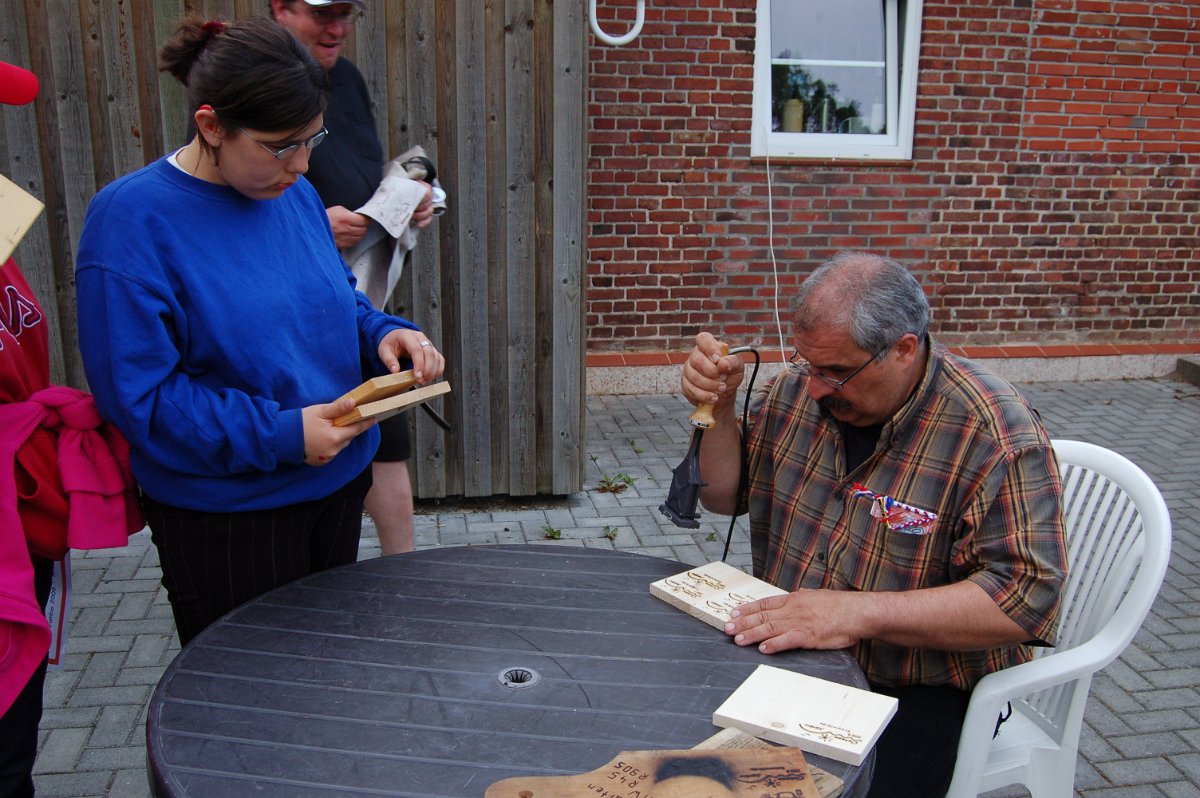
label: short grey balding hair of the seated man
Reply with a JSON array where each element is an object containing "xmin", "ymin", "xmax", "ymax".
[{"xmin": 794, "ymin": 252, "xmax": 929, "ymax": 353}]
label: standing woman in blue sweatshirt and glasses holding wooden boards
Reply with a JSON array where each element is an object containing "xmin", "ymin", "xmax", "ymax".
[{"xmin": 76, "ymin": 19, "xmax": 444, "ymax": 643}]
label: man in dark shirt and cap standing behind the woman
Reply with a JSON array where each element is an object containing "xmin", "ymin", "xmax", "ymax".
[{"xmin": 271, "ymin": 0, "xmax": 433, "ymax": 554}]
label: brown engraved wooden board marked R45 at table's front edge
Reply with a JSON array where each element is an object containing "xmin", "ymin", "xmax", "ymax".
[{"xmin": 484, "ymin": 748, "xmax": 821, "ymax": 798}]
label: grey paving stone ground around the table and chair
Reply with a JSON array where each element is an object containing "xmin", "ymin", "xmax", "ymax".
[{"xmin": 28, "ymin": 380, "xmax": 1200, "ymax": 798}]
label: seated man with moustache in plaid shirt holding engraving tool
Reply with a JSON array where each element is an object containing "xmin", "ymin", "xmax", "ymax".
[{"xmin": 683, "ymin": 253, "xmax": 1067, "ymax": 798}]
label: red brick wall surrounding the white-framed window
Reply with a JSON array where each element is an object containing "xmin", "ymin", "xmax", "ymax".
[{"xmin": 587, "ymin": 0, "xmax": 1200, "ymax": 352}]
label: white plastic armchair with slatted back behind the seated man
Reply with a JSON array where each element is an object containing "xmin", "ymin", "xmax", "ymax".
[{"xmin": 947, "ymin": 440, "xmax": 1171, "ymax": 798}]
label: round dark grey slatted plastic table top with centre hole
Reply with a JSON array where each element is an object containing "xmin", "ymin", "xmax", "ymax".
[{"xmin": 146, "ymin": 546, "xmax": 871, "ymax": 798}]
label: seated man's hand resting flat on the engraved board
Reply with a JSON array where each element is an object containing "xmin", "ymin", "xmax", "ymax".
[{"xmin": 725, "ymin": 590, "xmax": 864, "ymax": 654}]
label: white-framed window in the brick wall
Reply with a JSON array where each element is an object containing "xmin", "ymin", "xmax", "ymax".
[{"xmin": 750, "ymin": 0, "xmax": 922, "ymax": 160}]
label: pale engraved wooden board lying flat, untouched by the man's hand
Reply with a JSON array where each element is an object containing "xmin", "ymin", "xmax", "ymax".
[{"xmin": 713, "ymin": 665, "xmax": 898, "ymax": 766}]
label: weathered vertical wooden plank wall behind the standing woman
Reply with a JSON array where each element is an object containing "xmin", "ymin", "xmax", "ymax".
[{"xmin": 0, "ymin": 0, "xmax": 587, "ymax": 498}]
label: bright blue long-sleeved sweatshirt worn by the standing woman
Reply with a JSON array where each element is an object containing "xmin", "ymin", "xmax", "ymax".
[{"xmin": 76, "ymin": 158, "xmax": 418, "ymax": 512}]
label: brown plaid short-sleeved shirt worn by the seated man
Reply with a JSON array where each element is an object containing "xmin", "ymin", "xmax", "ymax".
[{"xmin": 743, "ymin": 342, "xmax": 1067, "ymax": 690}]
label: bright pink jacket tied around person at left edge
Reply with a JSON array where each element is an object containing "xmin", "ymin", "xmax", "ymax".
[{"xmin": 0, "ymin": 386, "xmax": 145, "ymax": 713}]
